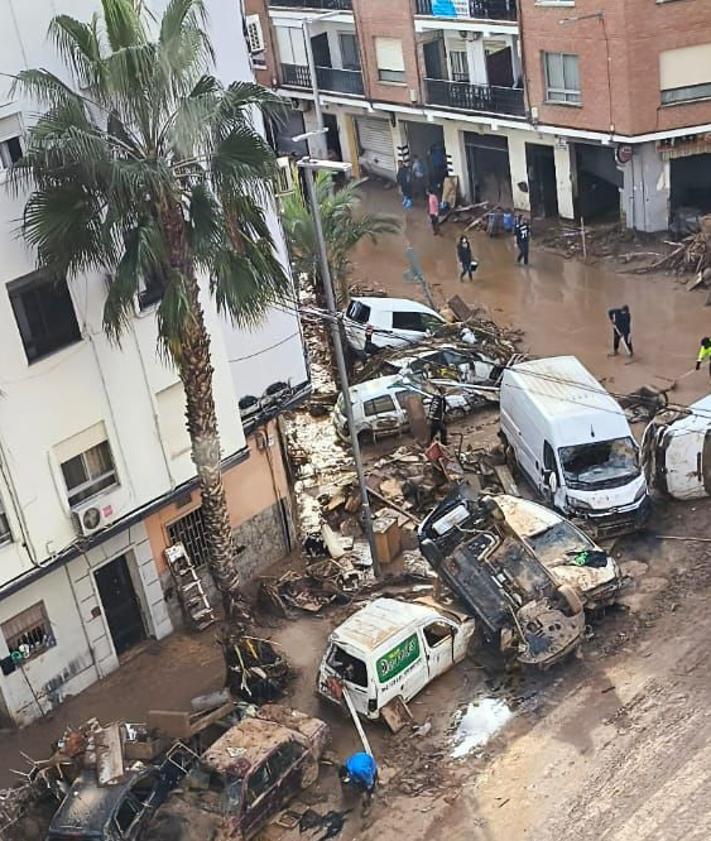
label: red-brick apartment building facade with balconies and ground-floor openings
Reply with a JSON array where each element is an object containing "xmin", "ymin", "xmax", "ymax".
[{"xmin": 245, "ymin": 0, "xmax": 711, "ymax": 231}]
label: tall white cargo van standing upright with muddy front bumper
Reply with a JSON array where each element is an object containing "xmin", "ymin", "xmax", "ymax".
[{"xmin": 500, "ymin": 356, "xmax": 650, "ymax": 537}]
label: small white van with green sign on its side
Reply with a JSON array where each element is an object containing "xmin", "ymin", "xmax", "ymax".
[{"xmin": 317, "ymin": 599, "xmax": 475, "ymax": 719}]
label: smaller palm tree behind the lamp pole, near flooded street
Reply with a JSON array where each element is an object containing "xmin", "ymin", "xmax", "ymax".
[{"xmin": 282, "ymin": 172, "xmax": 400, "ymax": 302}]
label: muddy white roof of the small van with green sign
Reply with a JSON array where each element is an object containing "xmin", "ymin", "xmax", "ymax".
[{"xmin": 331, "ymin": 599, "xmax": 437, "ymax": 651}]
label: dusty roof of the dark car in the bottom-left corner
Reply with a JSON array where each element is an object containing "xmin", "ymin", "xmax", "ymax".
[{"xmin": 49, "ymin": 769, "xmax": 142, "ymax": 839}]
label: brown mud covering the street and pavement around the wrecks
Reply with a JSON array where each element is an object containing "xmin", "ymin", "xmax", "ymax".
[{"xmin": 0, "ymin": 185, "xmax": 711, "ymax": 841}]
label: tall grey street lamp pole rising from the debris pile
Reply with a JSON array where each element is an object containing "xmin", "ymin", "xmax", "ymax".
[{"xmin": 300, "ymin": 161, "xmax": 380, "ymax": 576}]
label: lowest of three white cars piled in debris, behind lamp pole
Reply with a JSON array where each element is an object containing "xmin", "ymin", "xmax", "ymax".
[{"xmin": 332, "ymin": 374, "xmax": 478, "ymax": 441}]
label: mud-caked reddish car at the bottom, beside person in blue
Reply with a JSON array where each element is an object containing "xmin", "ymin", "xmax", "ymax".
[{"xmin": 152, "ymin": 704, "xmax": 329, "ymax": 841}]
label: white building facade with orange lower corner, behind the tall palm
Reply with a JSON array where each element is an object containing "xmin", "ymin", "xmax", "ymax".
[{"xmin": 0, "ymin": 0, "xmax": 309, "ymax": 727}]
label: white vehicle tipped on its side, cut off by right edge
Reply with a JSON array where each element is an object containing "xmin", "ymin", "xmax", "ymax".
[{"xmin": 645, "ymin": 395, "xmax": 711, "ymax": 499}]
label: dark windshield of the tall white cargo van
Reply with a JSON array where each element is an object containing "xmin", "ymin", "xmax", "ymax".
[{"xmin": 558, "ymin": 438, "xmax": 640, "ymax": 490}]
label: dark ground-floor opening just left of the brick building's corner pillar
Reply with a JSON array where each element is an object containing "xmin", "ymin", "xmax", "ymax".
[{"xmin": 575, "ymin": 143, "xmax": 624, "ymax": 220}]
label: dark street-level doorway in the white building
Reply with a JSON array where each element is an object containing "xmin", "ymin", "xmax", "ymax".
[{"xmin": 94, "ymin": 555, "xmax": 146, "ymax": 656}]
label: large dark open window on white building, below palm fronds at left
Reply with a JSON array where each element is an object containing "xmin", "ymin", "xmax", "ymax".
[{"xmin": 7, "ymin": 272, "xmax": 81, "ymax": 362}]
